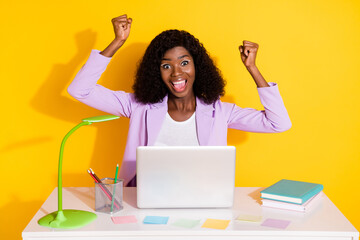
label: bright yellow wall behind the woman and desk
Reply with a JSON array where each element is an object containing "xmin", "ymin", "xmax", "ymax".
[{"xmin": 0, "ymin": 0, "xmax": 360, "ymax": 239}]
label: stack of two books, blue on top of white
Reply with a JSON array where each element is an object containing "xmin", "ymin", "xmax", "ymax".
[{"xmin": 261, "ymin": 179, "xmax": 324, "ymax": 212}]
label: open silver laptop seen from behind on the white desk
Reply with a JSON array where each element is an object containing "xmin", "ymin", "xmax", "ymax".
[{"xmin": 136, "ymin": 146, "xmax": 236, "ymax": 208}]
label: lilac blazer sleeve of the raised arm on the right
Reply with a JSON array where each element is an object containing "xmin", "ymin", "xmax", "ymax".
[{"xmin": 228, "ymin": 83, "xmax": 291, "ymax": 133}]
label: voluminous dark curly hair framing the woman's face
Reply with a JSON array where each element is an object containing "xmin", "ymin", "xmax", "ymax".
[{"xmin": 133, "ymin": 30, "xmax": 226, "ymax": 104}]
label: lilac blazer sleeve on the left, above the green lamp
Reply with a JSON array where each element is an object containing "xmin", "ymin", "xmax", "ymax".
[{"xmin": 67, "ymin": 50, "xmax": 134, "ymax": 117}]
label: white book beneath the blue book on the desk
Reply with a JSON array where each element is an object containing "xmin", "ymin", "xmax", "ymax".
[{"xmin": 261, "ymin": 192, "xmax": 322, "ymax": 212}]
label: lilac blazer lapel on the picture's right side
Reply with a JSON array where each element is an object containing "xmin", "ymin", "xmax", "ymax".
[{"xmin": 195, "ymin": 98, "xmax": 215, "ymax": 146}]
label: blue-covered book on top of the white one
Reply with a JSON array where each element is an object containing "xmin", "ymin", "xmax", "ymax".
[{"xmin": 260, "ymin": 179, "xmax": 324, "ymax": 204}]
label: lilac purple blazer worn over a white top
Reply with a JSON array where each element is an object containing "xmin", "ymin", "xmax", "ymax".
[{"xmin": 68, "ymin": 50, "xmax": 291, "ymax": 184}]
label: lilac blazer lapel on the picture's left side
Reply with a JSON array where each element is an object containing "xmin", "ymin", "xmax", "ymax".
[{"xmin": 146, "ymin": 96, "xmax": 167, "ymax": 146}]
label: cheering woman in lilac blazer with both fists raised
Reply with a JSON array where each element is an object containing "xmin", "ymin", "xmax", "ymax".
[{"xmin": 68, "ymin": 15, "xmax": 291, "ymax": 186}]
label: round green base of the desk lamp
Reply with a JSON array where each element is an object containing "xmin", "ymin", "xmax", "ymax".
[{"xmin": 38, "ymin": 209, "xmax": 97, "ymax": 229}]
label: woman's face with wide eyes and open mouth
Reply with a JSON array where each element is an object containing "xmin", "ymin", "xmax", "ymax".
[{"xmin": 160, "ymin": 47, "xmax": 195, "ymax": 98}]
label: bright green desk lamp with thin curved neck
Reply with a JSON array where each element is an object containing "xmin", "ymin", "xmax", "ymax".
[{"xmin": 38, "ymin": 115, "xmax": 119, "ymax": 229}]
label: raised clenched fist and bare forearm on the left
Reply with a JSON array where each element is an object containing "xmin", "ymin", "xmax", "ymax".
[{"xmin": 101, "ymin": 14, "xmax": 132, "ymax": 57}]
